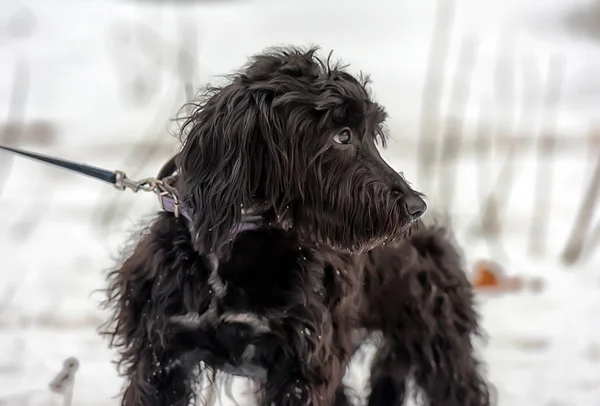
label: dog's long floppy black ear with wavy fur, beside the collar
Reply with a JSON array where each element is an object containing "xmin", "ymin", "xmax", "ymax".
[{"xmin": 177, "ymin": 83, "xmax": 272, "ymax": 253}]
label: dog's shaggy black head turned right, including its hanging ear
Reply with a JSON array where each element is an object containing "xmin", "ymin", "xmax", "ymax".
[{"xmin": 178, "ymin": 48, "xmax": 426, "ymax": 252}]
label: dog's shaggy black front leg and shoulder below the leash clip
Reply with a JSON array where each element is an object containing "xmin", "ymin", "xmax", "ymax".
[{"xmin": 106, "ymin": 214, "xmax": 210, "ymax": 406}]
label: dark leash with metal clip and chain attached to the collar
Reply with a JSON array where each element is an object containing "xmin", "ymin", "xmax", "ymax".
[{"xmin": 0, "ymin": 145, "xmax": 190, "ymax": 220}]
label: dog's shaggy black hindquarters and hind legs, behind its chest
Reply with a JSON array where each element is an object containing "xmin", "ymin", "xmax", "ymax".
[{"xmin": 367, "ymin": 229, "xmax": 490, "ymax": 406}]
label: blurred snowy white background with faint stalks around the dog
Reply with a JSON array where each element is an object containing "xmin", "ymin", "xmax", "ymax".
[{"xmin": 0, "ymin": 0, "xmax": 600, "ymax": 406}]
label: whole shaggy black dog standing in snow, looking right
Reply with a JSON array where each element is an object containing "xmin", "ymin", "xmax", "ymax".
[{"xmin": 103, "ymin": 48, "xmax": 490, "ymax": 406}]
